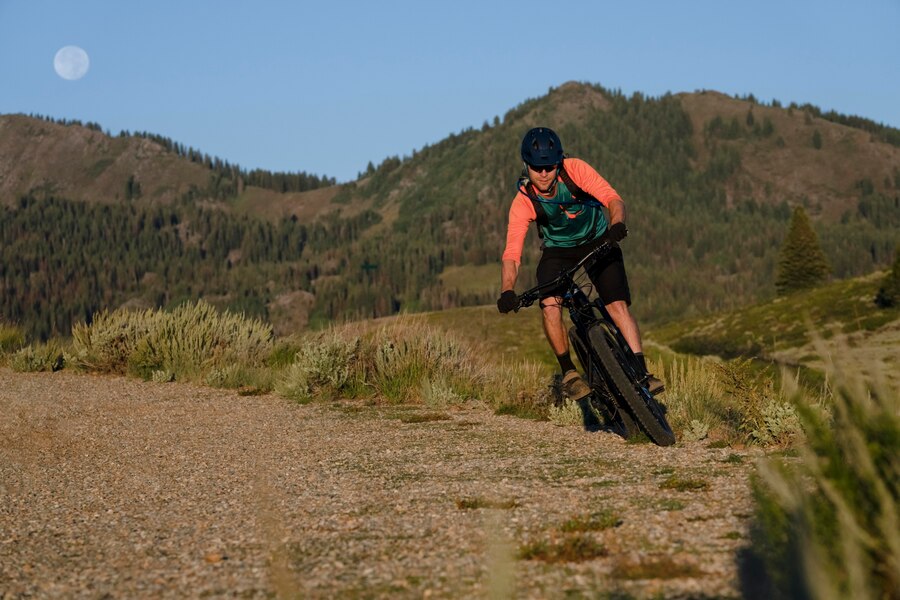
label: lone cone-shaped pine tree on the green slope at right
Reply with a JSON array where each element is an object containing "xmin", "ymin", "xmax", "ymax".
[{"xmin": 775, "ymin": 206, "xmax": 831, "ymax": 295}]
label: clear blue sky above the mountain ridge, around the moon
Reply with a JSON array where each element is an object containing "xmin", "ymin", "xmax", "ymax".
[{"xmin": 0, "ymin": 0, "xmax": 900, "ymax": 181}]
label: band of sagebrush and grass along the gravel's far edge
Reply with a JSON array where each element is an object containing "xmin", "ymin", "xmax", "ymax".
[{"xmin": 2, "ymin": 301, "xmax": 799, "ymax": 446}]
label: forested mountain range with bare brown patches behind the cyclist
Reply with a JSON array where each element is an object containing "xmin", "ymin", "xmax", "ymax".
[{"xmin": 0, "ymin": 83, "xmax": 900, "ymax": 336}]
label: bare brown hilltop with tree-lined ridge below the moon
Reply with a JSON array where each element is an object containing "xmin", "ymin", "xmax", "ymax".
[{"xmin": 0, "ymin": 114, "xmax": 334, "ymax": 207}]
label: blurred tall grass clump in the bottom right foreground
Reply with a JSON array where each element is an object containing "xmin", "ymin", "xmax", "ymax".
[{"xmin": 745, "ymin": 352, "xmax": 900, "ymax": 599}]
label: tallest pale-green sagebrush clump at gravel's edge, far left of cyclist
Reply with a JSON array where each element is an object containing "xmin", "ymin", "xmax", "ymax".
[{"xmin": 128, "ymin": 300, "xmax": 272, "ymax": 380}]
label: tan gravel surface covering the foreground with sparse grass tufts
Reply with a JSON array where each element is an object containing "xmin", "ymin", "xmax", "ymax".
[{"xmin": 0, "ymin": 369, "xmax": 753, "ymax": 598}]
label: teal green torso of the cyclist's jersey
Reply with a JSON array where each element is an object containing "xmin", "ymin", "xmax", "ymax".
[{"xmin": 538, "ymin": 181, "xmax": 607, "ymax": 248}]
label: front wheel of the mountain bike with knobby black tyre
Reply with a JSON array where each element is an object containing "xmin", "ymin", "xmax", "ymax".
[{"xmin": 588, "ymin": 323, "xmax": 675, "ymax": 446}]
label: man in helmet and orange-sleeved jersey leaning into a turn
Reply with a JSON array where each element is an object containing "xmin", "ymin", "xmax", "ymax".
[{"xmin": 497, "ymin": 127, "xmax": 665, "ymax": 401}]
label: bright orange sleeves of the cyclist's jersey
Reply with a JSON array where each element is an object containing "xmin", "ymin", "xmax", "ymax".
[{"xmin": 502, "ymin": 158, "xmax": 622, "ymax": 265}]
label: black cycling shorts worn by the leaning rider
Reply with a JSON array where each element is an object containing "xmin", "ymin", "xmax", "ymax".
[{"xmin": 537, "ymin": 240, "xmax": 631, "ymax": 305}]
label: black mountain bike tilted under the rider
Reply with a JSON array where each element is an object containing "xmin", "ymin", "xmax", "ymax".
[{"xmin": 515, "ymin": 242, "xmax": 675, "ymax": 446}]
